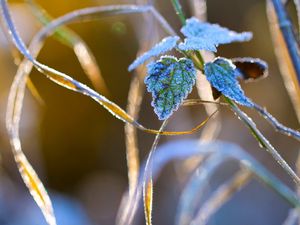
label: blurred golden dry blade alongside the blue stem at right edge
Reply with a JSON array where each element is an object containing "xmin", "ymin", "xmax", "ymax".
[{"xmin": 267, "ymin": 1, "xmax": 300, "ymax": 120}]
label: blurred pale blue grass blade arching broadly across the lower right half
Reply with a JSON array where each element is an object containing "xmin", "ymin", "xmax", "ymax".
[{"xmin": 117, "ymin": 139, "xmax": 300, "ymax": 225}]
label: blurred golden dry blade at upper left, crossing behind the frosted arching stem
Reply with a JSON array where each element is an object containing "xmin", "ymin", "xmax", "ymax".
[{"xmin": 26, "ymin": 0, "xmax": 109, "ymax": 95}]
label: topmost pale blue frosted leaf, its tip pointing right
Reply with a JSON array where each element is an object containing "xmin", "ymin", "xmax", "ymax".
[{"xmin": 179, "ymin": 17, "xmax": 252, "ymax": 52}]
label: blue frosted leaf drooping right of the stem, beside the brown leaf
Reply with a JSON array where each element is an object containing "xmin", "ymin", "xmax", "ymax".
[{"xmin": 204, "ymin": 57, "xmax": 254, "ymax": 108}]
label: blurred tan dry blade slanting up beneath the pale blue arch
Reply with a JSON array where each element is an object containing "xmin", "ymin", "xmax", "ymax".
[{"xmin": 191, "ymin": 169, "xmax": 252, "ymax": 225}]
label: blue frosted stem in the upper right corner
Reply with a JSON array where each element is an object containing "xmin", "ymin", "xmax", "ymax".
[{"xmin": 272, "ymin": 0, "xmax": 300, "ymax": 85}]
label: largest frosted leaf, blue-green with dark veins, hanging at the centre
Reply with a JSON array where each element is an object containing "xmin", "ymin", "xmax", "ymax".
[{"xmin": 145, "ymin": 56, "xmax": 196, "ymax": 120}]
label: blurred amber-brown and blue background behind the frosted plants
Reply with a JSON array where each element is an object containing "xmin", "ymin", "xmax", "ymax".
[{"xmin": 0, "ymin": 0, "xmax": 299, "ymax": 225}]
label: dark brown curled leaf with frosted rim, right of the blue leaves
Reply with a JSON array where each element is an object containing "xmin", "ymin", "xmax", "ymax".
[{"xmin": 231, "ymin": 57, "xmax": 268, "ymax": 81}]
